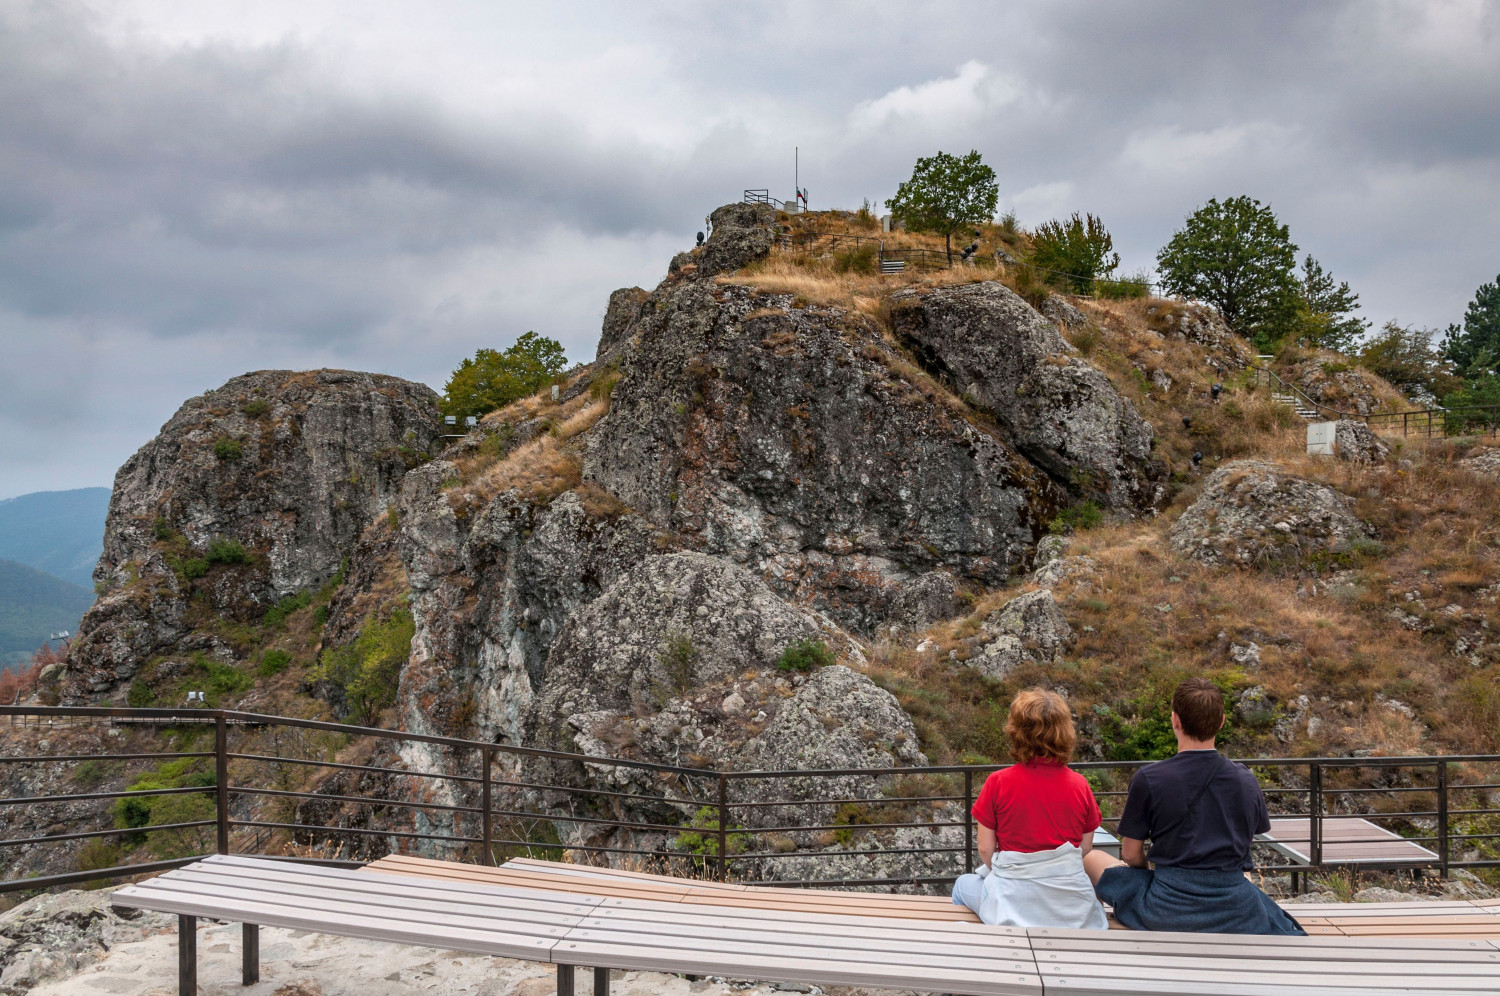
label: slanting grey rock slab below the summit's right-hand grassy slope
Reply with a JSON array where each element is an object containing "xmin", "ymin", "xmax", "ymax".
[{"xmin": 891, "ymin": 282, "xmax": 1161, "ymax": 510}]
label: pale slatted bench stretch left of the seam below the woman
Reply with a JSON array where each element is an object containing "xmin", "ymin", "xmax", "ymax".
[{"xmin": 111, "ymin": 857, "xmax": 1043, "ymax": 996}]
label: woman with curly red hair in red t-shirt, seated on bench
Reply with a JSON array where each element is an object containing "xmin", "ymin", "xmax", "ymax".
[{"xmin": 953, "ymin": 689, "xmax": 1109, "ymax": 930}]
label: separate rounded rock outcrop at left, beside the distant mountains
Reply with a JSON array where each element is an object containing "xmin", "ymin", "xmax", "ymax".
[{"xmin": 65, "ymin": 371, "xmax": 441, "ymax": 701}]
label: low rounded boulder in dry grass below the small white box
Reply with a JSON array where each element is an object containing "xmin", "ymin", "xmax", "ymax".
[{"xmin": 1170, "ymin": 461, "xmax": 1371, "ymax": 567}]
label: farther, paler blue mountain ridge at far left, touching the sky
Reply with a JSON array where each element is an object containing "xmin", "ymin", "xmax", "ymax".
[{"xmin": 0, "ymin": 488, "xmax": 110, "ymax": 590}]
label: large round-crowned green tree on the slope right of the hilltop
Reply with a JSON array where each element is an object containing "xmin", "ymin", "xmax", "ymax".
[{"xmin": 1157, "ymin": 197, "xmax": 1301, "ymax": 350}]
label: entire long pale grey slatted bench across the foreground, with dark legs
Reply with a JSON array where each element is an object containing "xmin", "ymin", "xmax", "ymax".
[{"xmin": 113, "ymin": 857, "xmax": 1500, "ymax": 996}]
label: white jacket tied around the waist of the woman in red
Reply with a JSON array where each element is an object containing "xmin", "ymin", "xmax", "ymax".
[{"xmin": 954, "ymin": 843, "xmax": 1110, "ymax": 930}]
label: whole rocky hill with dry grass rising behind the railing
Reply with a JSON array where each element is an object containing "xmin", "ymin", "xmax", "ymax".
[{"xmin": 14, "ymin": 204, "xmax": 1500, "ymax": 873}]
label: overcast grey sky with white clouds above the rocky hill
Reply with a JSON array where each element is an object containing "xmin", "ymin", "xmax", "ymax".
[{"xmin": 0, "ymin": 0, "xmax": 1500, "ymax": 498}]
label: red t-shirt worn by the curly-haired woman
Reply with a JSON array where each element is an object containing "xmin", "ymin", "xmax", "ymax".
[{"xmin": 974, "ymin": 761, "xmax": 1100, "ymax": 854}]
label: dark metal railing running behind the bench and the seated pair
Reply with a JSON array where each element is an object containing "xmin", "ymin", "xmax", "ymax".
[{"xmin": 0, "ymin": 707, "xmax": 1500, "ymax": 893}]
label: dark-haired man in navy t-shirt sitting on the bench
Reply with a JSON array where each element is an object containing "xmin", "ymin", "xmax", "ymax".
[{"xmin": 1085, "ymin": 678, "xmax": 1305, "ymax": 935}]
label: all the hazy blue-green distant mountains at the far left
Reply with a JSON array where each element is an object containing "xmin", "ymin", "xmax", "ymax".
[{"xmin": 0, "ymin": 488, "xmax": 110, "ymax": 668}]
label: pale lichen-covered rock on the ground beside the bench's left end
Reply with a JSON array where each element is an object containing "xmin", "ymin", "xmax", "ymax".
[{"xmin": 0, "ymin": 890, "xmax": 177, "ymax": 996}]
